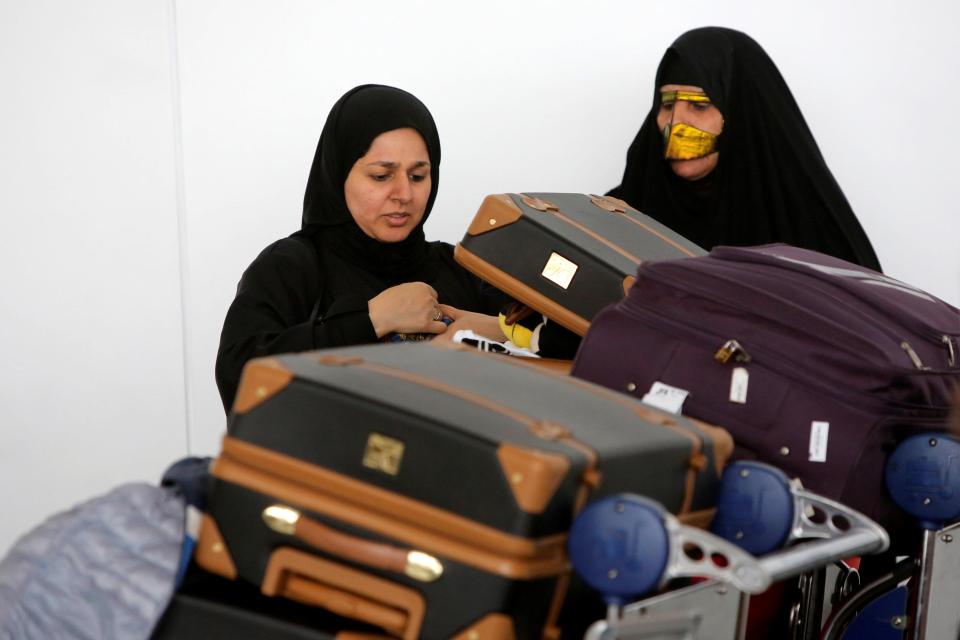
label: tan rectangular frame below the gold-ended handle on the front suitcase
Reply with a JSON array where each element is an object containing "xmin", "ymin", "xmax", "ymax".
[{"xmin": 260, "ymin": 547, "xmax": 426, "ymax": 640}]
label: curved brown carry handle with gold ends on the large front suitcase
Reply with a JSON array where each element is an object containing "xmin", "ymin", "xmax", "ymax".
[{"xmin": 263, "ymin": 504, "xmax": 443, "ymax": 582}]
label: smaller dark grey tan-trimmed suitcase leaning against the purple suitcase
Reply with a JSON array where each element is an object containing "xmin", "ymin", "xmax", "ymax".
[{"xmin": 454, "ymin": 193, "xmax": 705, "ymax": 336}]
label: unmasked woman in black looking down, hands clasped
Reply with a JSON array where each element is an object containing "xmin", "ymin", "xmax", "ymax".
[{"xmin": 216, "ymin": 85, "xmax": 504, "ymax": 411}]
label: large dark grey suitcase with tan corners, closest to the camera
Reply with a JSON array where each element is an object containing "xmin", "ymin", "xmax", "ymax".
[{"xmin": 197, "ymin": 343, "xmax": 732, "ymax": 638}]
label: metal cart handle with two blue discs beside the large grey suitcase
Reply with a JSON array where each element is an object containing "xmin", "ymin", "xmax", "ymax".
[{"xmin": 569, "ymin": 462, "xmax": 889, "ymax": 640}]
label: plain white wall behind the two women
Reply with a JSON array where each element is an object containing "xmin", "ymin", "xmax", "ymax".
[{"xmin": 0, "ymin": 0, "xmax": 960, "ymax": 554}]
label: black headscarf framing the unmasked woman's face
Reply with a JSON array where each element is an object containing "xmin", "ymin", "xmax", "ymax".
[{"xmin": 301, "ymin": 84, "xmax": 440, "ymax": 283}]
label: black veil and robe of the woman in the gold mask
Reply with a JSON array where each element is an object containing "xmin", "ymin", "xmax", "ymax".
[{"xmin": 611, "ymin": 27, "xmax": 880, "ymax": 271}]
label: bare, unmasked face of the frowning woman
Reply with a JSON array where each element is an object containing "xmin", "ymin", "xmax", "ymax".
[{"xmin": 343, "ymin": 128, "xmax": 431, "ymax": 242}]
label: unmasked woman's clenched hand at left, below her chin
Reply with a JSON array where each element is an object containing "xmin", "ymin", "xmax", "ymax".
[{"xmin": 367, "ymin": 282, "xmax": 452, "ymax": 338}]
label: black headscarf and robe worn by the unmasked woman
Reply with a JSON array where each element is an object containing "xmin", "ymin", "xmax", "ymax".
[{"xmin": 216, "ymin": 85, "xmax": 503, "ymax": 411}]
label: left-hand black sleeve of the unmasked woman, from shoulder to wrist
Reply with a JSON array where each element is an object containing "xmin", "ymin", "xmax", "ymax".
[{"xmin": 215, "ymin": 238, "xmax": 377, "ymax": 413}]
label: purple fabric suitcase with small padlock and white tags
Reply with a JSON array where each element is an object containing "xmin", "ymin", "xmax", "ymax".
[{"xmin": 572, "ymin": 244, "xmax": 960, "ymax": 527}]
